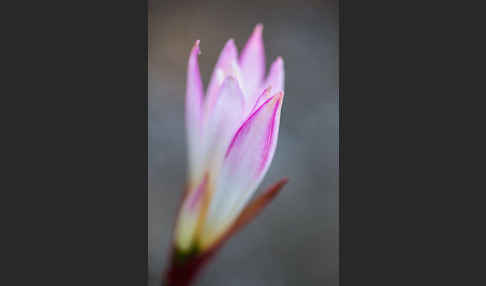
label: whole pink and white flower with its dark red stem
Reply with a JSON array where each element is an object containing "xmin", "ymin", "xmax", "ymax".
[{"xmin": 167, "ymin": 25, "xmax": 286, "ymax": 285}]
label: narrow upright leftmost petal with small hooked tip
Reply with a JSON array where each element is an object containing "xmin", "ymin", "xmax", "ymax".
[{"xmin": 186, "ymin": 40, "xmax": 204, "ymax": 185}]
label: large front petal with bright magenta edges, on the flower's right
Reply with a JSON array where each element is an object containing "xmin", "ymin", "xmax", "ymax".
[{"xmin": 201, "ymin": 93, "xmax": 283, "ymax": 248}]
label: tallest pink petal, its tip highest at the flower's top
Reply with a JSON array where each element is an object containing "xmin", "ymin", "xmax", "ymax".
[{"xmin": 240, "ymin": 24, "xmax": 265, "ymax": 103}]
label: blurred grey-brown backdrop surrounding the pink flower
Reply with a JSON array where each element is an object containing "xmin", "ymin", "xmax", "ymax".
[{"xmin": 148, "ymin": 0, "xmax": 339, "ymax": 286}]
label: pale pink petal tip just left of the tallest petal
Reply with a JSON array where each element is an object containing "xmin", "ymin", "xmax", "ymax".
[{"xmin": 206, "ymin": 39, "xmax": 238, "ymax": 114}]
